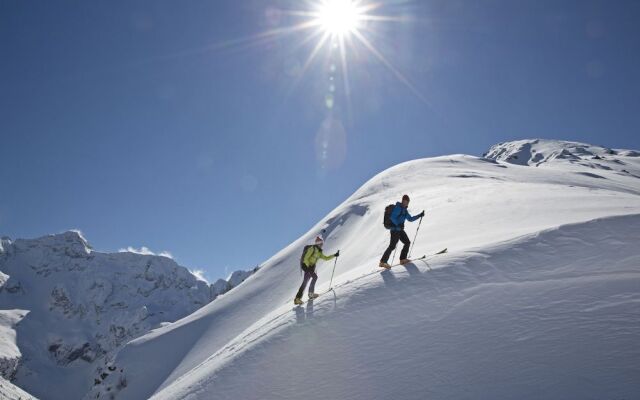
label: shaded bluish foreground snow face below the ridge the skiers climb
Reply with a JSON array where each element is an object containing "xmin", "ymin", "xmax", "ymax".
[{"xmin": 154, "ymin": 215, "xmax": 640, "ymax": 399}]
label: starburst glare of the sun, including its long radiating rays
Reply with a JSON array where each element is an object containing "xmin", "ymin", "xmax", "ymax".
[{"xmin": 215, "ymin": 0, "xmax": 425, "ymax": 104}]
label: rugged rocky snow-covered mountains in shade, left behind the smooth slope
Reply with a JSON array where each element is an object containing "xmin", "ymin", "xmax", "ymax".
[{"xmin": 0, "ymin": 231, "xmax": 253, "ymax": 400}]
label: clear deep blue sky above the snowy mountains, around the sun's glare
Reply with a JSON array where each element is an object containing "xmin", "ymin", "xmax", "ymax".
[{"xmin": 0, "ymin": 0, "xmax": 640, "ymax": 279}]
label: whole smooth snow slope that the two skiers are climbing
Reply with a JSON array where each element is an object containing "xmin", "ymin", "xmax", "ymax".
[{"xmin": 87, "ymin": 140, "xmax": 640, "ymax": 399}]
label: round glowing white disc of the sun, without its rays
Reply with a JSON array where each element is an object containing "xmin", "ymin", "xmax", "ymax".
[{"xmin": 316, "ymin": 0, "xmax": 363, "ymax": 36}]
